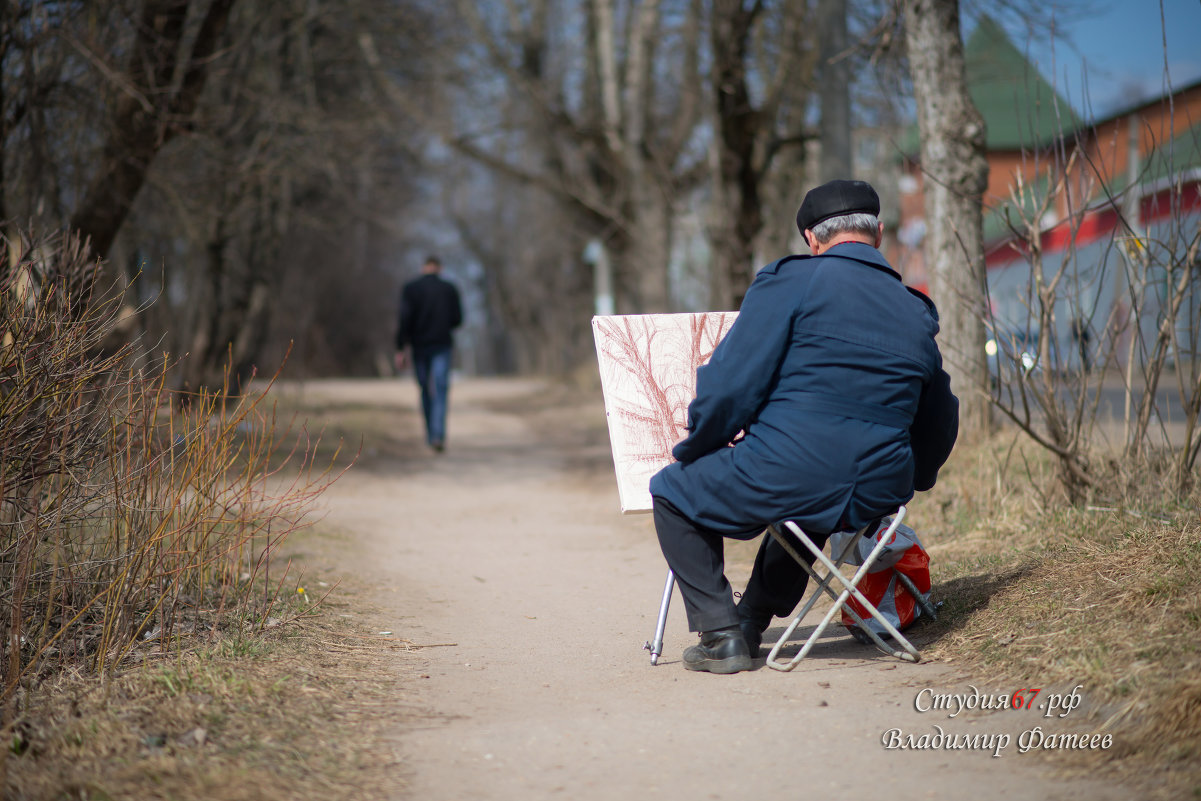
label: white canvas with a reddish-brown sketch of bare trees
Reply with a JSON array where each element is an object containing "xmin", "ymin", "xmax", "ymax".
[{"xmin": 592, "ymin": 311, "xmax": 737, "ymax": 513}]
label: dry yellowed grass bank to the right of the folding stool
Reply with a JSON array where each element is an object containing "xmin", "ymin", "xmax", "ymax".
[{"xmin": 920, "ymin": 435, "xmax": 1201, "ymax": 797}]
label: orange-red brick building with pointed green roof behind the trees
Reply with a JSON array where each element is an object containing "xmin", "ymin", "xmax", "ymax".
[{"xmin": 888, "ymin": 17, "xmax": 1201, "ymax": 294}]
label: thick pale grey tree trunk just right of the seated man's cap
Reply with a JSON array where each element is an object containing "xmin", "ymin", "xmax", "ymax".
[{"xmin": 902, "ymin": 0, "xmax": 990, "ymax": 432}]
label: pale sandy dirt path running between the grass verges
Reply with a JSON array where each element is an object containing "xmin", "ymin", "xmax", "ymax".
[{"xmin": 285, "ymin": 381, "xmax": 1134, "ymax": 801}]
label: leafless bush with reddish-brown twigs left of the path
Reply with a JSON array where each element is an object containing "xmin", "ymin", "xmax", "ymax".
[{"xmin": 0, "ymin": 230, "xmax": 345, "ymax": 713}]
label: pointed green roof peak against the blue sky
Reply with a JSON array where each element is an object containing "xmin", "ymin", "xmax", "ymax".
[{"xmin": 963, "ymin": 14, "xmax": 1081, "ymax": 150}]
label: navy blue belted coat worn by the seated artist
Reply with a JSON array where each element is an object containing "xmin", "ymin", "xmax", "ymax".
[{"xmin": 651, "ymin": 243, "xmax": 958, "ymax": 534}]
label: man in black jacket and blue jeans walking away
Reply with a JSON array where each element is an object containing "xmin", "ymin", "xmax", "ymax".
[{"xmin": 396, "ymin": 256, "xmax": 462, "ymax": 453}]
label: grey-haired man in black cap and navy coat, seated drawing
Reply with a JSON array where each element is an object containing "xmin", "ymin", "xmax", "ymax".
[{"xmin": 651, "ymin": 180, "xmax": 958, "ymax": 674}]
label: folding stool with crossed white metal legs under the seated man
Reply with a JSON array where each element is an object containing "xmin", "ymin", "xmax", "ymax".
[{"xmin": 767, "ymin": 506, "xmax": 921, "ymax": 670}]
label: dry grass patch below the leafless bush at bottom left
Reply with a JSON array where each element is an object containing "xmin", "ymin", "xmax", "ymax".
[{"xmin": 4, "ymin": 576, "xmax": 420, "ymax": 801}]
